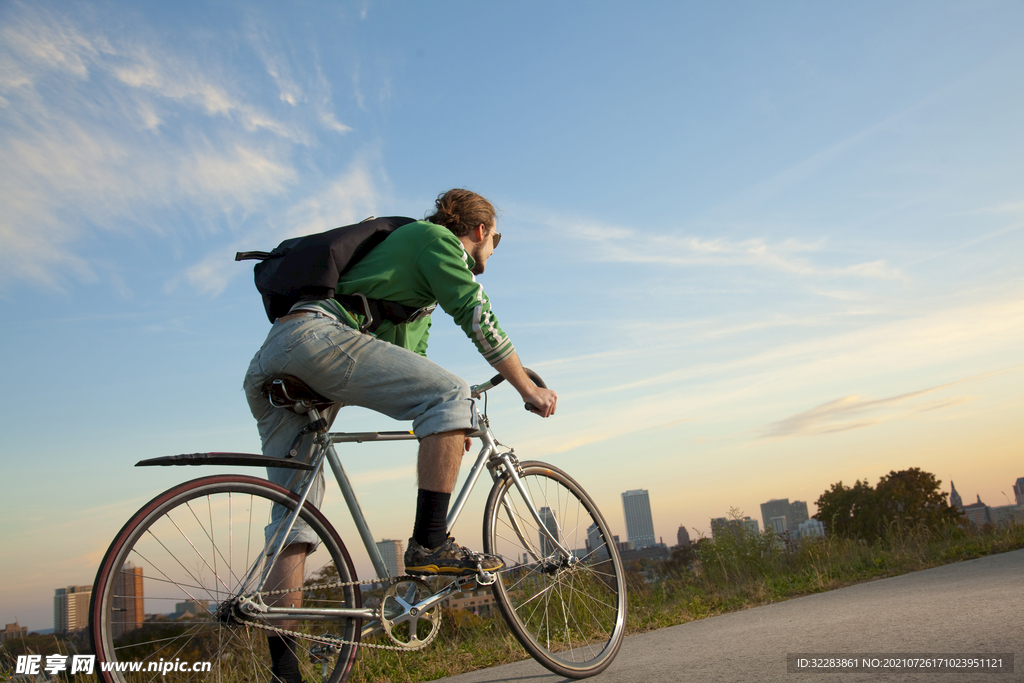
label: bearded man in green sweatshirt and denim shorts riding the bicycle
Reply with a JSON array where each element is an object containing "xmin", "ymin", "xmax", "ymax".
[{"xmin": 245, "ymin": 189, "xmax": 557, "ymax": 680}]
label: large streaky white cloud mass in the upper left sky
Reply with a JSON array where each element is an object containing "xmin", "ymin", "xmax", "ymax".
[{"xmin": 0, "ymin": 3, "xmax": 358, "ymax": 290}]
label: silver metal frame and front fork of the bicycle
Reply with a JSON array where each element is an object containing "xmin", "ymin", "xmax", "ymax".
[{"xmin": 243, "ymin": 395, "xmax": 573, "ymax": 636}]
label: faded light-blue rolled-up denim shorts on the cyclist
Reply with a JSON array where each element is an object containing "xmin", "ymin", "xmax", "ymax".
[{"xmin": 244, "ymin": 313, "xmax": 476, "ymax": 544}]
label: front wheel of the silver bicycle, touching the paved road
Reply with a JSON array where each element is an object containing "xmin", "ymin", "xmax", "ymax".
[{"xmin": 483, "ymin": 462, "xmax": 626, "ymax": 678}]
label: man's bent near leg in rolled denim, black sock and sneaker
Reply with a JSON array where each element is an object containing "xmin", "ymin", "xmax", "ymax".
[{"xmin": 246, "ymin": 318, "xmax": 502, "ymax": 574}]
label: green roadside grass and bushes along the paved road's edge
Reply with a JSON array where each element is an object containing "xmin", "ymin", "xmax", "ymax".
[{"xmin": 337, "ymin": 468, "xmax": 1024, "ymax": 683}]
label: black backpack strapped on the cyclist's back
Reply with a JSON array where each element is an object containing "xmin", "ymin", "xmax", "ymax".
[{"xmin": 234, "ymin": 216, "xmax": 423, "ymax": 331}]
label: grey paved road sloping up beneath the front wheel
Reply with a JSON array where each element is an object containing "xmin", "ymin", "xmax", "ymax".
[{"xmin": 441, "ymin": 550, "xmax": 1024, "ymax": 683}]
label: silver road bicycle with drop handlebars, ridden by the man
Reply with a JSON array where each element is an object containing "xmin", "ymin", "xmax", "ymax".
[{"xmin": 89, "ymin": 371, "xmax": 627, "ymax": 683}]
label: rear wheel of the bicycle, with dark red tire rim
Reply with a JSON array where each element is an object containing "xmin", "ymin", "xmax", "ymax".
[{"xmin": 89, "ymin": 475, "xmax": 360, "ymax": 683}]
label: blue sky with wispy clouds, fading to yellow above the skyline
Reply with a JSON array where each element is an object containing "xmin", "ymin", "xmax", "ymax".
[{"xmin": 0, "ymin": 1, "xmax": 1024, "ymax": 629}]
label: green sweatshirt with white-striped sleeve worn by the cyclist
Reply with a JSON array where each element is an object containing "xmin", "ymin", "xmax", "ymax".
[{"xmin": 303, "ymin": 221, "xmax": 514, "ymax": 365}]
